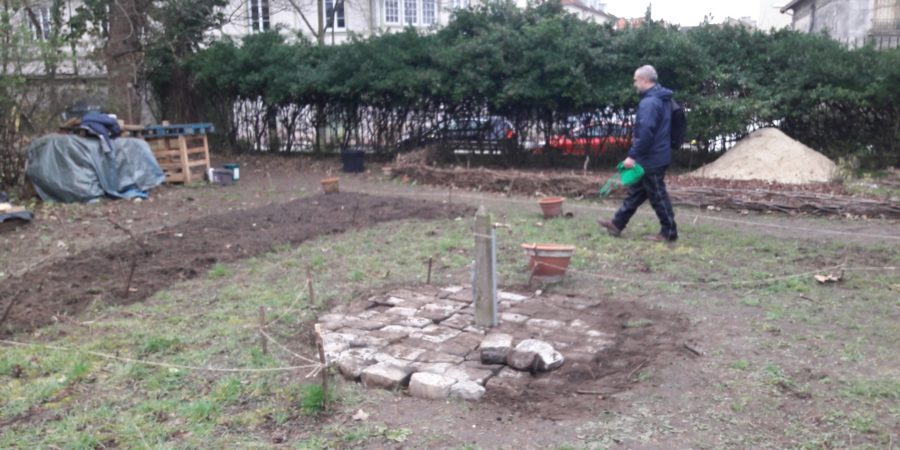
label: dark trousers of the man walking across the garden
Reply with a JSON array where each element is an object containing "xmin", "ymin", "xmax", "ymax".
[{"xmin": 613, "ymin": 166, "xmax": 678, "ymax": 240}]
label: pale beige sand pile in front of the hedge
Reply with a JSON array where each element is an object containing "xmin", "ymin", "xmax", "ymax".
[{"xmin": 689, "ymin": 128, "xmax": 835, "ymax": 184}]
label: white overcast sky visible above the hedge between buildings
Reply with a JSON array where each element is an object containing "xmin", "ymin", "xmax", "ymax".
[{"xmin": 603, "ymin": 0, "xmax": 760, "ymax": 26}]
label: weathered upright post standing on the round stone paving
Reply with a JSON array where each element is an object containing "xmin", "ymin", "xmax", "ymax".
[{"xmin": 472, "ymin": 205, "xmax": 497, "ymax": 327}]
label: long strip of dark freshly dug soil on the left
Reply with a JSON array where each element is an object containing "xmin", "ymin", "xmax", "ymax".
[{"xmin": 0, "ymin": 194, "xmax": 469, "ymax": 336}]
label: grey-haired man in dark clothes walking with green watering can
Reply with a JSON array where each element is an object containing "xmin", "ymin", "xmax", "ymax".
[{"xmin": 598, "ymin": 66, "xmax": 678, "ymax": 242}]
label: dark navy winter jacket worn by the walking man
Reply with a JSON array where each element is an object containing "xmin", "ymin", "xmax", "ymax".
[{"xmin": 628, "ymin": 84, "xmax": 672, "ymax": 169}]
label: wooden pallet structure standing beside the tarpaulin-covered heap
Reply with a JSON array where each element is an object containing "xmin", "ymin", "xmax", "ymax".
[{"xmin": 144, "ymin": 134, "xmax": 210, "ymax": 184}]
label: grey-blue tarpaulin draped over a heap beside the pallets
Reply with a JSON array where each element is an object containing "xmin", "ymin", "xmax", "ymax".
[{"xmin": 26, "ymin": 134, "xmax": 165, "ymax": 203}]
